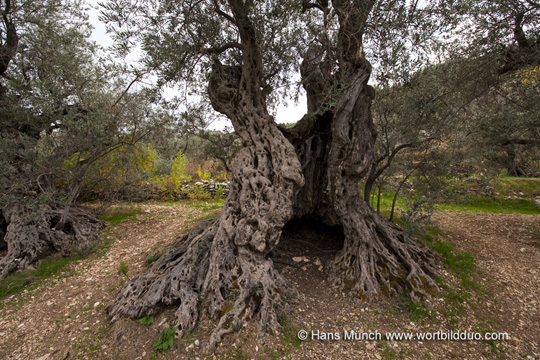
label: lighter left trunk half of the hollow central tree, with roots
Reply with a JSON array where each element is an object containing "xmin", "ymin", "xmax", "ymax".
[{"xmin": 108, "ymin": 0, "xmax": 303, "ymax": 351}]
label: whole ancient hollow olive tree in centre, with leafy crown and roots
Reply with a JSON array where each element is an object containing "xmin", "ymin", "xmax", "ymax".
[{"xmin": 107, "ymin": 0, "xmax": 437, "ymax": 350}]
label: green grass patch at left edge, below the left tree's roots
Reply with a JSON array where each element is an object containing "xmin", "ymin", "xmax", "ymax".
[{"xmin": 0, "ymin": 255, "xmax": 80, "ymax": 300}]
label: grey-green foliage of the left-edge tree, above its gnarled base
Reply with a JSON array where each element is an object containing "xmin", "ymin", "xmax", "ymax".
[{"xmin": 0, "ymin": 1, "xmax": 166, "ymax": 207}]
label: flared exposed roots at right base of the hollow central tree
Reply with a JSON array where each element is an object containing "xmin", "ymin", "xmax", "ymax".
[{"xmin": 330, "ymin": 206, "xmax": 439, "ymax": 306}]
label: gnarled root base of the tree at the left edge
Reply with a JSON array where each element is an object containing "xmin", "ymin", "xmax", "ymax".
[{"xmin": 0, "ymin": 204, "xmax": 105, "ymax": 279}]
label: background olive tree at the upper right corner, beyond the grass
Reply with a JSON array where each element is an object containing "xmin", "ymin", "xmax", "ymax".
[{"xmin": 442, "ymin": 0, "xmax": 540, "ymax": 176}]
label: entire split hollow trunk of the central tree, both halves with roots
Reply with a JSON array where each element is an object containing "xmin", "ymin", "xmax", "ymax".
[{"xmin": 107, "ymin": 0, "xmax": 437, "ymax": 351}]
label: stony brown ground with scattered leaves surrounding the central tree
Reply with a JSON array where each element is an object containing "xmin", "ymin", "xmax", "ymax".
[{"xmin": 0, "ymin": 201, "xmax": 540, "ymax": 360}]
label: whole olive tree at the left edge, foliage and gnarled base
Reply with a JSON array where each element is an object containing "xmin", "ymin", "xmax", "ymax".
[{"xmin": 0, "ymin": 0, "xmax": 158, "ymax": 277}]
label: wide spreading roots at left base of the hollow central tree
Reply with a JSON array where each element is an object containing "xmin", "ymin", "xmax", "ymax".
[{"xmin": 107, "ymin": 215, "xmax": 296, "ymax": 352}]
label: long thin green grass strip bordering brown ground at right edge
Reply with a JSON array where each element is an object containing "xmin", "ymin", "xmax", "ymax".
[{"xmin": 437, "ymin": 196, "xmax": 540, "ymax": 214}]
